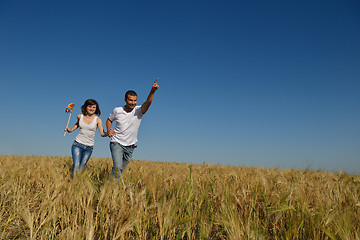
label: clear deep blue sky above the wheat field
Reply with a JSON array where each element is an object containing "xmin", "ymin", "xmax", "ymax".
[{"xmin": 0, "ymin": 0, "xmax": 360, "ymax": 173}]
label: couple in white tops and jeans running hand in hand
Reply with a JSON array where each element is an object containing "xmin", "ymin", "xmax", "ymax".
[{"xmin": 65, "ymin": 79, "xmax": 159, "ymax": 178}]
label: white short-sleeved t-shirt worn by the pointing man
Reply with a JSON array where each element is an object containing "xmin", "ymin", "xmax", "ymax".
[{"xmin": 109, "ymin": 106, "xmax": 144, "ymax": 146}]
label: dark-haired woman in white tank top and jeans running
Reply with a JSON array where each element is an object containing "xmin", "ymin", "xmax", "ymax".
[{"xmin": 65, "ymin": 99, "xmax": 108, "ymax": 176}]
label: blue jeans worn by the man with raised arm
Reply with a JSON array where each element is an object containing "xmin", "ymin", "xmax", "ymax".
[{"xmin": 110, "ymin": 142, "xmax": 134, "ymax": 179}]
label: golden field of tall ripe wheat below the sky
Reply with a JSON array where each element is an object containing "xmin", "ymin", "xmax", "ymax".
[{"xmin": 0, "ymin": 156, "xmax": 360, "ymax": 239}]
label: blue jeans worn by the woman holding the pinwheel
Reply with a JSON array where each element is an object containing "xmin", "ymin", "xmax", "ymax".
[{"xmin": 71, "ymin": 141, "xmax": 93, "ymax": 176}]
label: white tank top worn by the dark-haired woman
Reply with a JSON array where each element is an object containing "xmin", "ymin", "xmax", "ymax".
[{"xmin": 75, "ymin": 114, "xmax": 97, "ymax": 146}]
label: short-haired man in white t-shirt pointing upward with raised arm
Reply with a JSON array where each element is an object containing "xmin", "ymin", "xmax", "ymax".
[{"xmin": 106, "ymin": 79, "xmax": 159, "ymax": 178}]
